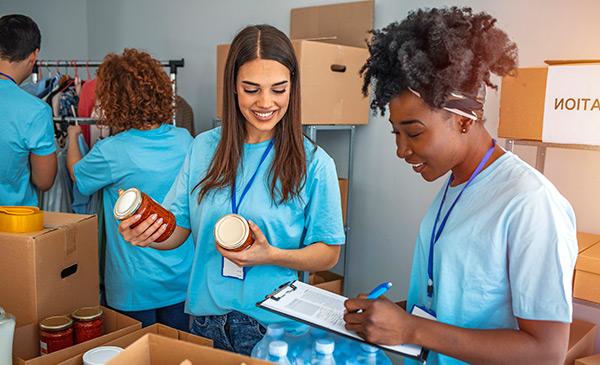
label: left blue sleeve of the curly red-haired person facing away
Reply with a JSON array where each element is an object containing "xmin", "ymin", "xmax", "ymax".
[{"xmin": 73, "ymin": 142, "xmax": 114, "ymax": 195}]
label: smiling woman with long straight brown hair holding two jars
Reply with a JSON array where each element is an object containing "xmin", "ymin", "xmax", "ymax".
[{"xmin": 120, "ymin": 25, "xmax": 345, "ymax": 354}]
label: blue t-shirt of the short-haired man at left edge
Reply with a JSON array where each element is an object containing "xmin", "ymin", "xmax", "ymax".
[{"xmin": 0, "ymin": 80, "xmax": 56, "ymax": 206}]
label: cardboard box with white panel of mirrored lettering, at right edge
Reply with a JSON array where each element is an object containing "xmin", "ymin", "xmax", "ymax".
[{"xmin": 498, "ymin": 60, "xmax": 600, "ymax": 145}]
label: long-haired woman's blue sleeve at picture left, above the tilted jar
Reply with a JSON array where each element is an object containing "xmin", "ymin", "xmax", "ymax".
[{"xmin": 162, "ymin": 148, "xmax": 193, "ymax": 229}]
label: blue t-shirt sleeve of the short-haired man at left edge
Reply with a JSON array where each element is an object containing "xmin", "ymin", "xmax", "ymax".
[{"xmin": 25, "ymin": 106, "xmax": 56, "ymax": 156}]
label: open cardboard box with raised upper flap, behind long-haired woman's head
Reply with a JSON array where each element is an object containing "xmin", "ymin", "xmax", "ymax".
[{"xmin": 216, "ymin": 1, "xmax": 373, "ymax": 125}]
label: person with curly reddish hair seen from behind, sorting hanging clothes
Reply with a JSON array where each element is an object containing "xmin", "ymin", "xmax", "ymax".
[{"xmin": 67, "ymin": 49, "xmax": 194, "ymax": 331}]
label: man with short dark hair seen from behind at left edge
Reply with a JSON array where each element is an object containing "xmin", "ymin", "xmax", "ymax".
[{"xmin": 0, "ymin": 15, "xmax": 56, "ymax": 206}]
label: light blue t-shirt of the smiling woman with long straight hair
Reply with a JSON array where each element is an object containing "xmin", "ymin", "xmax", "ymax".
[{"xmin": 164, "ymin": 128, "xmax": 345, "ymax": 325}]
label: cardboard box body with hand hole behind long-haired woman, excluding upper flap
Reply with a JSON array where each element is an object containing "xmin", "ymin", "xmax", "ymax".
[{"xmin": 216, "ymin": 40, "xmax": 369, "ymax": 124}]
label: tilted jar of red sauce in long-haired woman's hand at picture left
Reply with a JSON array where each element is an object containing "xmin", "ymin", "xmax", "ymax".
[{"xmin": 113, "ymin": 188, "xmax": 177, "ymax": 242}]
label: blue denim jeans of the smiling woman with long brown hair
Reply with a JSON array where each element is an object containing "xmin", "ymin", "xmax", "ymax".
[{"xmin": 190, "ymin": 311, "xmax": 266, "ymax": 356}]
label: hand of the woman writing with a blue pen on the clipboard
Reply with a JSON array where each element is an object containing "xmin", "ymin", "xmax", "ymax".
[{"xmin": 344, "ymin": 296, "xmax": 415, "ymax": 345}]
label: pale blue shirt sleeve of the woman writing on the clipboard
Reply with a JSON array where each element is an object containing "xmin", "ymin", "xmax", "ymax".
[{"xmin": 508, "ymin": 188, "xmax": 577, "ymax": 322}]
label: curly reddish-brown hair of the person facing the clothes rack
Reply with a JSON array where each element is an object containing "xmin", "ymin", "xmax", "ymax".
[{"xmin": 96, "ymin": 49, "xmax": 173, "ymax": 133}]
